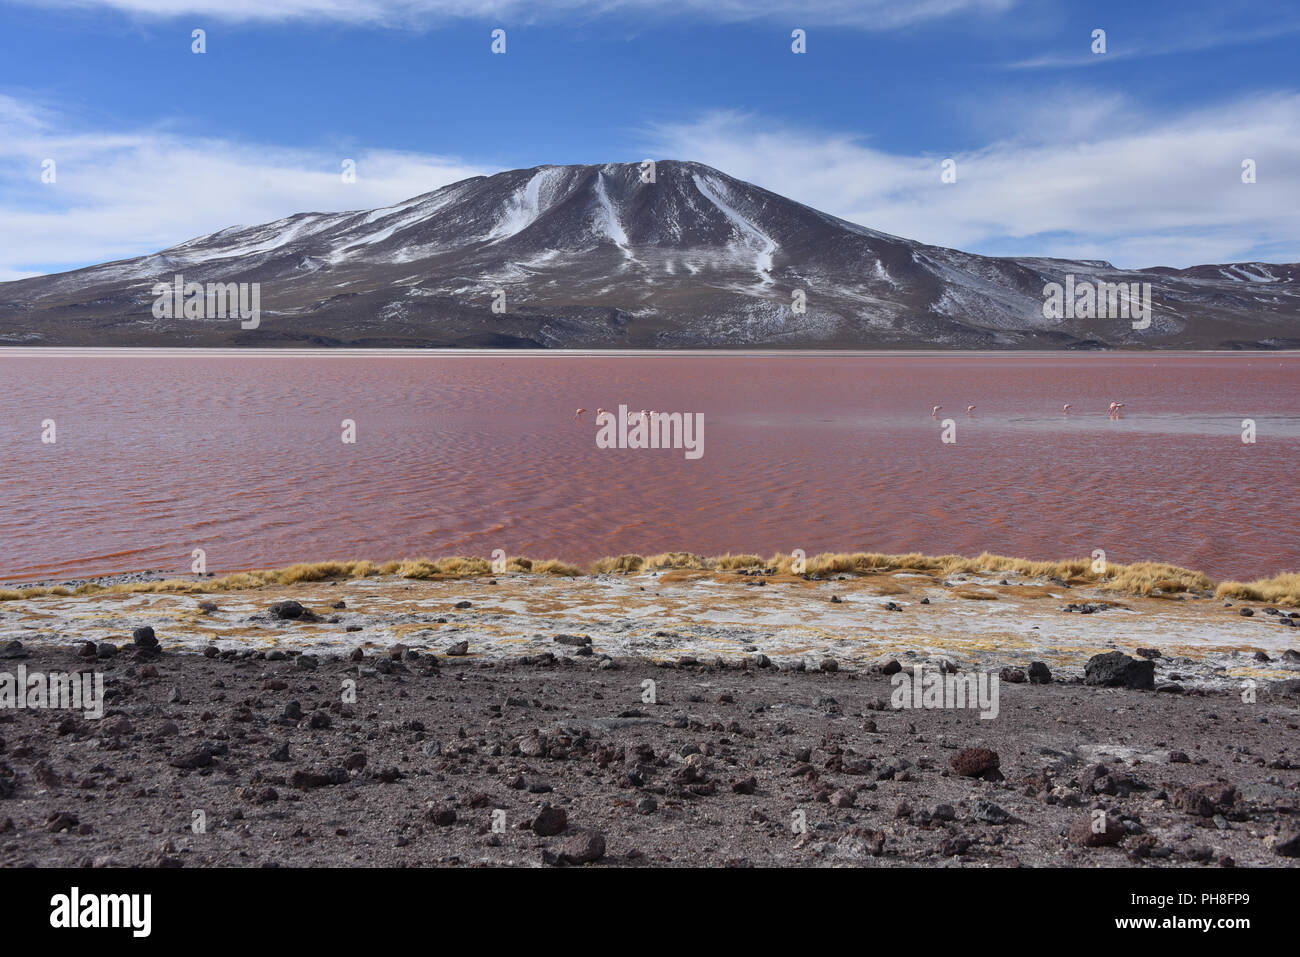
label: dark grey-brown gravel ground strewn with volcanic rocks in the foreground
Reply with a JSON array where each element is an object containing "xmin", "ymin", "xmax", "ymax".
[{"xmin": 0, "ymin": 637, "xmax": 1300, "ymax": 867}]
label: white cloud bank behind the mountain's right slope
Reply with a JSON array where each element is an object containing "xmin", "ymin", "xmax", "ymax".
[{"xmin": 650, "ymin": 91, "xmax": 1300, "ymax": 267}]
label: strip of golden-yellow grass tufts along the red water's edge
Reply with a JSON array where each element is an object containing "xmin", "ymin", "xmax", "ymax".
[{"xmin": 0, "ymin": 551, "xmax": 1300, "ymax": 605}]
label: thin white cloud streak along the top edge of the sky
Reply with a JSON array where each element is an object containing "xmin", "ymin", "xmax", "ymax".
[{"xmin": 7, "ymin": 0, "xmax": 1018, "ymax": 30}]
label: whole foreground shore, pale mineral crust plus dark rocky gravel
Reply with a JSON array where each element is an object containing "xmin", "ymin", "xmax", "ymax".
[{"xmin": 0, "ymin": 570, "xmax": 1300, "ymax": 866}]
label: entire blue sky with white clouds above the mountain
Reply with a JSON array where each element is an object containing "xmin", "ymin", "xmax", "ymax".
[{"xmin": 0, "ymin": 0, "xmax": 1300, "ymax": 280}]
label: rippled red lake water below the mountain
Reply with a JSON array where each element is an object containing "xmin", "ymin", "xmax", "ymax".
[{"xmin": 0, "ymin": 351, "xmax": 1300, "ymax": 580}]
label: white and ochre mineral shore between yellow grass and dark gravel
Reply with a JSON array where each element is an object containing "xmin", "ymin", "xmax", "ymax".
[{"xmin": 0, "ymin": 555, "xmax": 1300, "ymax": 689}]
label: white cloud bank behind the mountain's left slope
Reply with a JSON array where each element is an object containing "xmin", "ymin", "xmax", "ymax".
[{"xmin": 0, "ymin": 95, "xmax": 494, "ymax": 280}]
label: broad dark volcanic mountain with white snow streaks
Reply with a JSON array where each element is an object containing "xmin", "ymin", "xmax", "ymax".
[{"xmin": 0, "ymin": 160, "xmax": 1300, "ymax": 348}]
